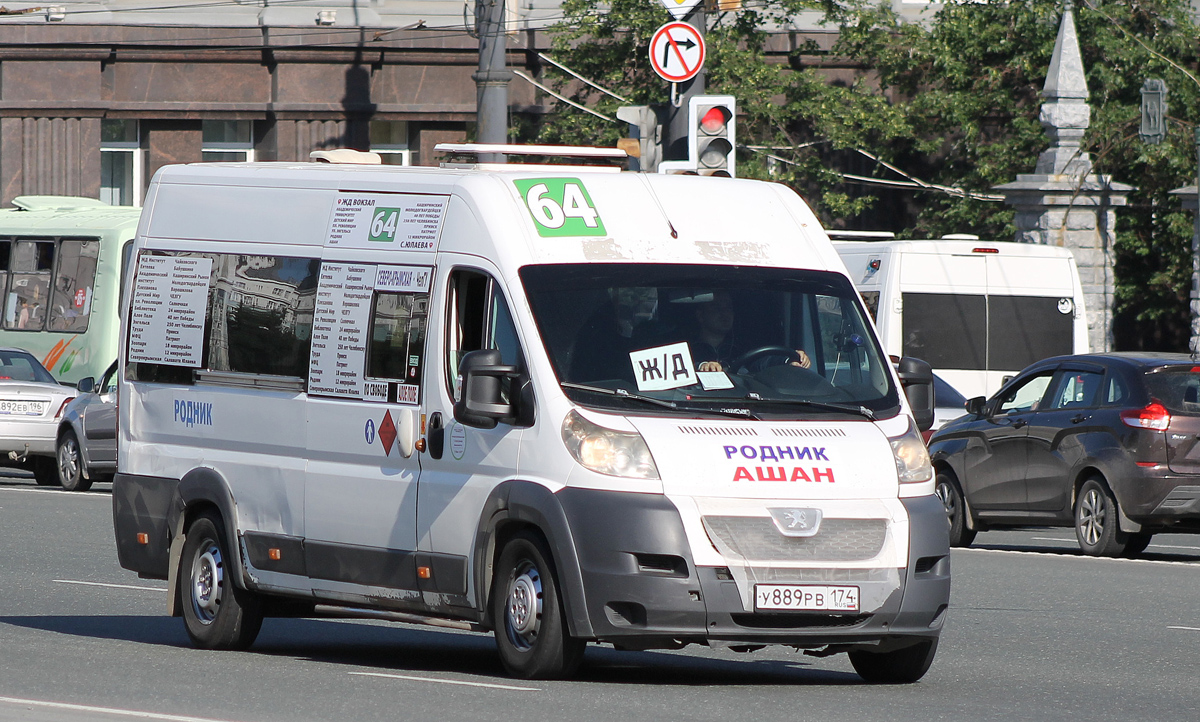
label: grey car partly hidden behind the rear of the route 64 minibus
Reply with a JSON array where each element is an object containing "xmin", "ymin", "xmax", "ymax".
[{"xmin": 56, "ymin": 361, "xmax": 116, "ymax": 492}]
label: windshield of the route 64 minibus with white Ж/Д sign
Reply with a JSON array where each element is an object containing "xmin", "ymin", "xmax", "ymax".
[{"xmin": 521, "ymin": 263, "xmax": 899, "ymax": 419}]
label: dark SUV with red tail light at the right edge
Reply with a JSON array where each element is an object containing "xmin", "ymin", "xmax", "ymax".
[{"xmin": 929, "ymin": 353, "xmax": 1200, "ymax": 556}]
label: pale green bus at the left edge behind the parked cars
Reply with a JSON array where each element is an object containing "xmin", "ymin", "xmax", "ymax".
[{"xmin": 0, "ymin": 195, "xmax": 140, "ymax": 384}]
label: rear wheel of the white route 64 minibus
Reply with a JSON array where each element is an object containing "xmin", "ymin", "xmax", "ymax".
[{"xmin": 179, "ymin": 512, "xmax": 263, "ymax": 649}]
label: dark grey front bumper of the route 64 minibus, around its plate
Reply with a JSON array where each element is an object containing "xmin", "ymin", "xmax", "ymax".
[{"xmin": 557, "ymin": 488, "xmax": 950, "ymax": 649}]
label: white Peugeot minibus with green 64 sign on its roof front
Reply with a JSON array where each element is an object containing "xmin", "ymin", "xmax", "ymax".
[{"xmin": 113, "ymin": 151, "xmax": 950, "ymax": 681}]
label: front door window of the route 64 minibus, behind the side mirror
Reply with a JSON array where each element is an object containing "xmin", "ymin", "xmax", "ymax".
[{"xmin": 446, "ymin": 270, "xmax": 523, "ymax": 398}]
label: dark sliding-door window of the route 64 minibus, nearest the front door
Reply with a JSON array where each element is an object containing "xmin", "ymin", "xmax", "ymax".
[{"xmin": 366, "ymin": 293, "xmax": 430, "ymax": 384}]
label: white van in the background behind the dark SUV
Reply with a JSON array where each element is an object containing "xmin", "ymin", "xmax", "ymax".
[{"xmin": 834, "ymin": 235, "xmax": 1088, "ymax": 398}]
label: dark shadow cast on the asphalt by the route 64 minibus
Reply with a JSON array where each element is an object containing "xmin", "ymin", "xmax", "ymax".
[{"xmin": 0, "ymin": 615, "xmax": 864, "ymax": 687}]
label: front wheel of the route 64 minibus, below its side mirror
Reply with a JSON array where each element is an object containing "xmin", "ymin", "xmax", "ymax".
[{"xmin": 492, "ymin": 533, "xmax": 587, "ymax": 679}]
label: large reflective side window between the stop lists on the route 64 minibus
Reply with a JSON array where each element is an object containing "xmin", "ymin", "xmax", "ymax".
[{"xmin": 204, "ymin": 254, "xmax": 320, "ymax": 378}]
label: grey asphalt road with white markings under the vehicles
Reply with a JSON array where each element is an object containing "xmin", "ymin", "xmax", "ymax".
[{"xmin": 0, "ymin": 474, "xmax": 1200, "ymax": 722}]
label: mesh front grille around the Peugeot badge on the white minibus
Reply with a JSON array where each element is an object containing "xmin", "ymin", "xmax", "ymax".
[{"xmin": 703, "ymin": 517, "xmax": 888, "ymax": 561}]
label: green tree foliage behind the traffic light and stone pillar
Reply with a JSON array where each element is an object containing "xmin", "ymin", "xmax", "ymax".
[{"xmin": 538, "ymin": 0, "xmax": 1200, "ymax": 350}]
